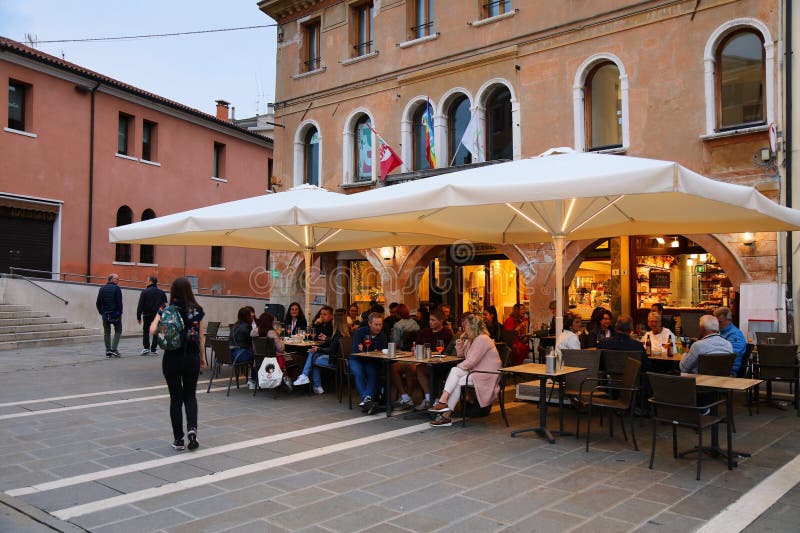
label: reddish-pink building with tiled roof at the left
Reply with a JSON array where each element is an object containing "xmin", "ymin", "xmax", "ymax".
[{"xmin": 0, "ymin": 38, "xmax": 272, "ymax": 296}]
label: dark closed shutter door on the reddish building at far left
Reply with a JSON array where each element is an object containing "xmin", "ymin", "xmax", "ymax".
[{"xmin": 0, "ymin": 215, "xmax": 53, "ymax": 278}]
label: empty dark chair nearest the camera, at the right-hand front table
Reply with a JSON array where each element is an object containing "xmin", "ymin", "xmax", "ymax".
[{"xmin": 647, "ymin": 372, "xmax": 733, "ymax": 480}]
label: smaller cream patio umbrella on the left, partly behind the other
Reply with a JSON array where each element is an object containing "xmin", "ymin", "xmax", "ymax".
[{"xmin": 109, "ymin": 185, "xmax": 450, "ymax": 312}]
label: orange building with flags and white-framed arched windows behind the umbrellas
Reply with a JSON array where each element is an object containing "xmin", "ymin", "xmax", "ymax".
[{"xmin": 259, "ymin": 0, "xmax": 783, "ymax": 330}]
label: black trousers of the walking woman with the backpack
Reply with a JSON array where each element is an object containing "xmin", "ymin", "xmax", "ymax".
[{"xmin": 161, "ymin": 347, "xmax": 200, "ymax": 440}]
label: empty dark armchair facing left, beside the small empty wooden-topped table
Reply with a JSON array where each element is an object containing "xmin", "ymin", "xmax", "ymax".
[{"xmin": 575, "ymin": 357, "xmax": 642, "ymax": 452}]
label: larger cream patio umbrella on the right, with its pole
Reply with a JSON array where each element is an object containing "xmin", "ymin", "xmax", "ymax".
[{"xmin": 312, "ymin": 148, "xmax": 800, "ymax": 332}]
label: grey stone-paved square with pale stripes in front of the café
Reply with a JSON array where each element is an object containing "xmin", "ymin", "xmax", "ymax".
[{"xmin": 0, "ymin": 338, "xmax": 800, "ymax": 532}]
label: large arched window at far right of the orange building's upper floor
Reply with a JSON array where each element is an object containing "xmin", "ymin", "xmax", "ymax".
[{"xmin": 716, "ymin": 30, "xmax": 766, "ymax": 130}]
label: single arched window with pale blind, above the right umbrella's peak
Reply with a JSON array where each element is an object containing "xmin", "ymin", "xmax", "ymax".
[{"xmin": 584, "ymin": 61, "xmax": 622, "ymax": 150}]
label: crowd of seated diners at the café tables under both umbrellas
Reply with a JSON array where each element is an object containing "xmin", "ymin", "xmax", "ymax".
[{"xmin": 223, "ymin": 302, "xmax": 747, "ymax": 427}]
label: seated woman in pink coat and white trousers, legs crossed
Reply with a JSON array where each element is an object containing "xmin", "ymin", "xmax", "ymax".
[{"xmin": 429, "ymin": 315, "xmax": 502, "ymax": 427}]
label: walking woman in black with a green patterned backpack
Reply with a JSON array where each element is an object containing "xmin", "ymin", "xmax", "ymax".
[{"xmin": 150, "ymin": 278, "xmax": 205, "ymax": 450}]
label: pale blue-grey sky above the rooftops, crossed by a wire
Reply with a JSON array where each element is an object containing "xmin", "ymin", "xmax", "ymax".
[{"xmin": 0, "ymin": 0, "xmax": 275, "ymax": 118}]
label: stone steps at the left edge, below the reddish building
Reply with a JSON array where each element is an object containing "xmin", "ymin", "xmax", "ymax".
[{"xmin": 0, "ymin": 304, "xmax": 103, "ymax": 350}]
